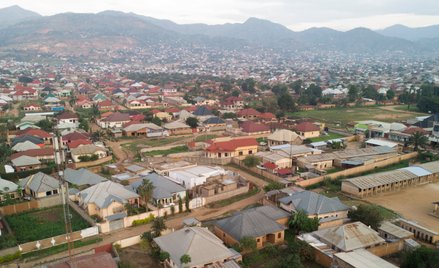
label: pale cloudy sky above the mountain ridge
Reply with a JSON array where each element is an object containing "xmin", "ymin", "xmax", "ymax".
[{"xmin": 0, "ymin": 0, "xmax": 439, "ymax": 30}]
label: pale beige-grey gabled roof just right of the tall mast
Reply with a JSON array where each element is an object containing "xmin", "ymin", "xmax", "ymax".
[{"xmin": 78, "ymin": 181, "xmax": 139, "ymax": 208}]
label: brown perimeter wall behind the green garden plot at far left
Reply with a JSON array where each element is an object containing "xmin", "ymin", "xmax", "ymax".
[{"xmin": 0, "ymin": 195, "xmax": 62, "ymax": 216}]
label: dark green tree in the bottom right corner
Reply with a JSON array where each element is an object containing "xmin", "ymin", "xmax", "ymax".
[{"xmin": 401, "ymin": 246, "xmax": 439, "ymax": 268}]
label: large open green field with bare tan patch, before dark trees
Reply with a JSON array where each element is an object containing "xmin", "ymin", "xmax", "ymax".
[{"xmin": 288, "ymin": 105, "xmax": 423, "ymax": 126}]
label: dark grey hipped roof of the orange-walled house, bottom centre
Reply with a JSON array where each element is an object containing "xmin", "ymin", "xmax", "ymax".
[{"xmin": 215, "ymin": 205, "xmax": 289, "ymax": 241}]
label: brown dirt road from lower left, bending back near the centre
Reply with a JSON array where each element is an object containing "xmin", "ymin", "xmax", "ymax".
[{"xmin": 20, "ymin": 167, "xmax": 267, "ymax": 267}]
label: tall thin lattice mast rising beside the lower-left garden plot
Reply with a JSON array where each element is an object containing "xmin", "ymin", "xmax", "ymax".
[{"xmin": 53, "ymin": 130, "xmax": 74, "ymax": 258}]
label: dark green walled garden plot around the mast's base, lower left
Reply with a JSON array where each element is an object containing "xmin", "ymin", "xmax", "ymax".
[{"xmin": 6, "ymin": 206, "xmax": 89, "ymax": 244}]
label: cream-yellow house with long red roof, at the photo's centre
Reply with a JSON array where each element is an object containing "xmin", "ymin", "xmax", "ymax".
[{"xmin": 205, "ymin": 138, "xmax": 258, "ymax": 158}]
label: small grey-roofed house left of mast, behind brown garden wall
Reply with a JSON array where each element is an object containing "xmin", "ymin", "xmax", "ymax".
[{"xmin": 18, "ymin": 172, "xmax": 60, "ymax": 198}]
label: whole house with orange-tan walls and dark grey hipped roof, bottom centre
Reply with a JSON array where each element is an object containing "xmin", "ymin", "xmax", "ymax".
[{"xmin": 214, "ymin": 206, "xmax": 290, "ymax": 249}]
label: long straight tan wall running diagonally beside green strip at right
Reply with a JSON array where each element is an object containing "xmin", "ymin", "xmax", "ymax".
[{"xmin": 296, "ymin": 152, "xmax": 418, "ymax": 187}]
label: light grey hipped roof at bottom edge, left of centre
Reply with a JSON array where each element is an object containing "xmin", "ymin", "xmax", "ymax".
[{"xmin": 154, "ymin": 227, "xmax": 235, "ymax": 267}]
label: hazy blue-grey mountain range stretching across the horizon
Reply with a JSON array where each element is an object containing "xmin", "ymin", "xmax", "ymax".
[{"xmin": 0, "ymin": 6, "xmax": 439, "ymax": 55}]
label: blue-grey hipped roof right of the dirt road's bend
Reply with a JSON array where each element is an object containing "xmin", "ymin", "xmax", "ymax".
[{"xmin": 279, "ymin": 191, "xmax": 349, "ymax": 215}]
